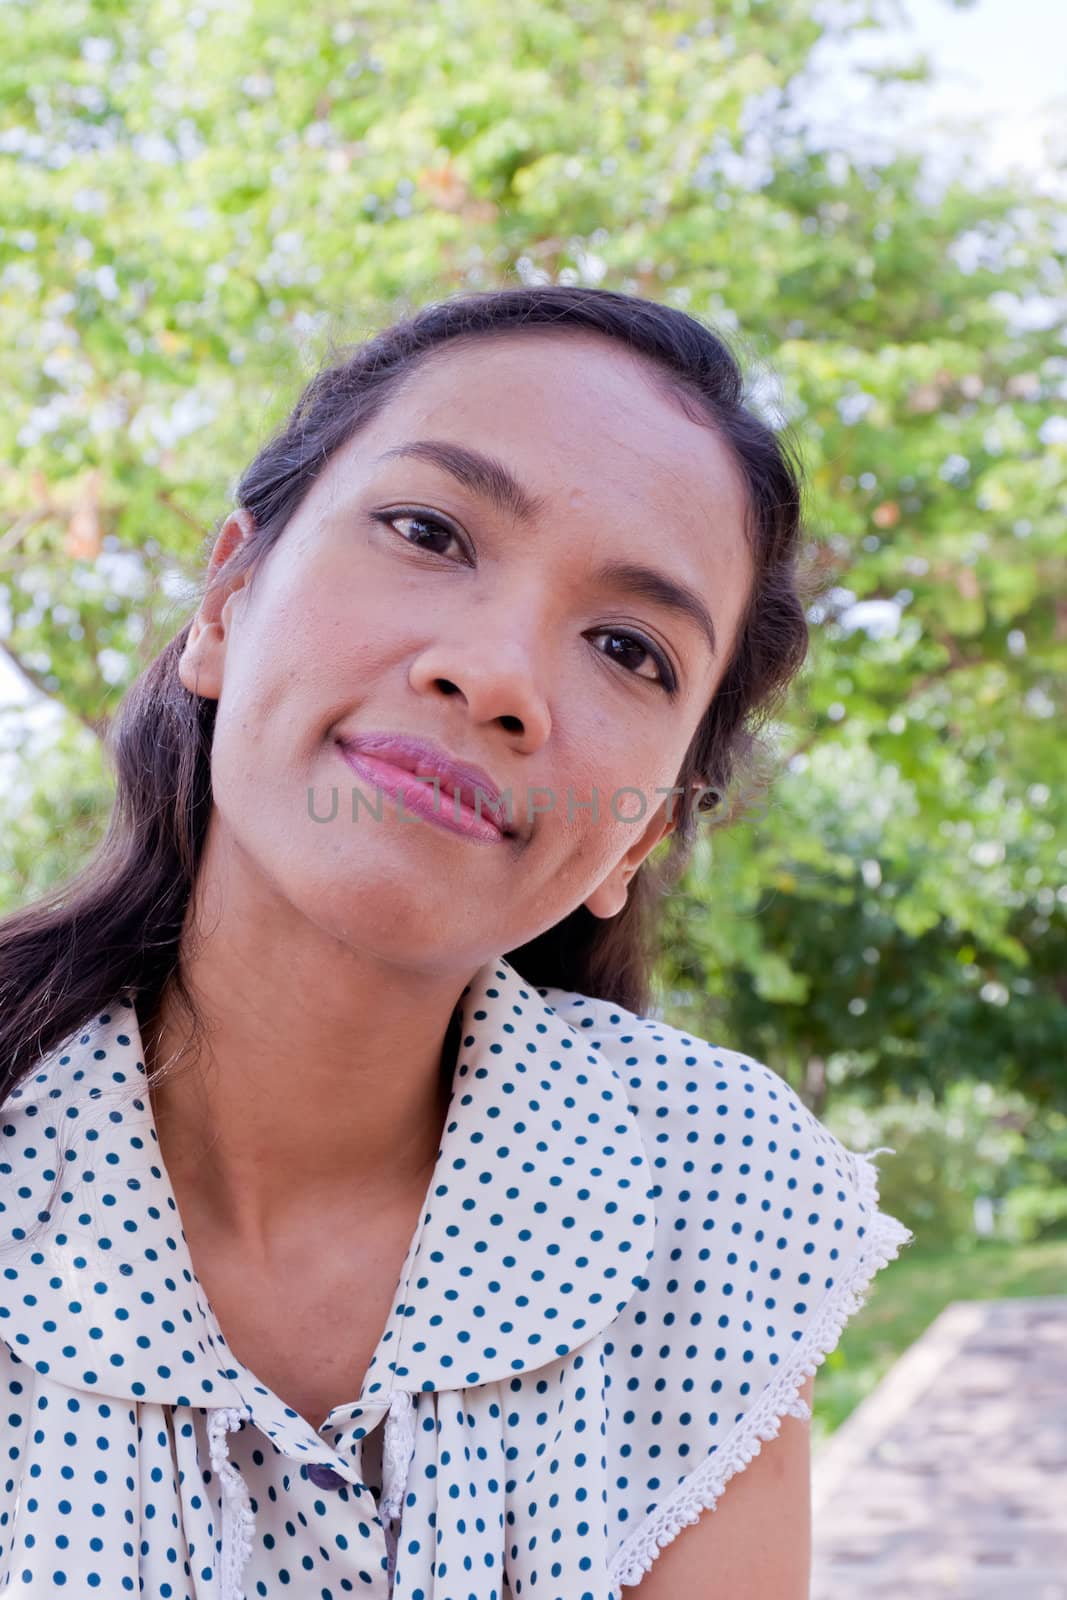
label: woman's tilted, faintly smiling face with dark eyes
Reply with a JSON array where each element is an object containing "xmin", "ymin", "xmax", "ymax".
[{"xmin": 181, "ymin": 331, "xmax": 752, "ymax": 973}]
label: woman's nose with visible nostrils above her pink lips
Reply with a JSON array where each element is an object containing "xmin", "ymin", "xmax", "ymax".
[{"xmin": 408, "ymin": 634, "xmax": 552, "ymax": 750}]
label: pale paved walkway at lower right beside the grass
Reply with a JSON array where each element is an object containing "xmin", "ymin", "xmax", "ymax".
[{"xmin": 811, "ymin": 1294, "xmax": 1067, "ymax": 1600}]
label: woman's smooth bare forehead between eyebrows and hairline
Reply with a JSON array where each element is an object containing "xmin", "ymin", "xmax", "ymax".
[{"xmin": 338, "ymin": 330, "xmax": 747, "ymax": 541}]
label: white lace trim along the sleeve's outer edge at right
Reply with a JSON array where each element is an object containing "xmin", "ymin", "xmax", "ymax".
[{"xmin": 611, "ymin": 1146, "xmax": 915, "ymax": 1600}]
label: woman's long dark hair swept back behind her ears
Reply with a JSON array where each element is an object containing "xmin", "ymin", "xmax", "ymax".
[{"xmin": 0, "ymin": 285, "xmax": 814, "ymax": 1098}]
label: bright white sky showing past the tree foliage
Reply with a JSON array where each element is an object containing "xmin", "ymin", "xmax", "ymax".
[{"xmin": 0, "ymin": 0, "xmax": 1067, "ymax": 752}]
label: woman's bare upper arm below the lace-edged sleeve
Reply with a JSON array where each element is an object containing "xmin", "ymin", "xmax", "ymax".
[{"xmin": 622, "ymin": 1378, "xmax": 814, "ymax": 1600}]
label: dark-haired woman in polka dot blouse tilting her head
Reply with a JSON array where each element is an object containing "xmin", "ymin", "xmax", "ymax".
[{"xmin": 0, "ymin": 286, "xmax": 910, "ymax": 1600}]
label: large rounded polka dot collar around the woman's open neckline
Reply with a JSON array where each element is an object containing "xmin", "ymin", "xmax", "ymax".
[{"xmin": 0, "ymin": 957, "xmax": 654, "ymax": 1418}]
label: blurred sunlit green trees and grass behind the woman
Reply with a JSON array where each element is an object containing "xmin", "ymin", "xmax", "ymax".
[{"xmin": 0, "ymin": 0, "xmax": 1067, "ymax": 1438}]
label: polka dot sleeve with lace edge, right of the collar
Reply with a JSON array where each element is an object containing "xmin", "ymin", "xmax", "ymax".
[{"xmin": 563, "ymin": 1000, "xmax": 913, "ymax": 1595}]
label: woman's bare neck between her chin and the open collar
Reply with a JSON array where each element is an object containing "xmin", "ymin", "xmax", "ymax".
[{"xmin": 139, "ymin": 851, "xmax": 472, "ymax": 1254}]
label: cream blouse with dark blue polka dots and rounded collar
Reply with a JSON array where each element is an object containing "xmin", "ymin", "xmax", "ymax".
[{"xmin": 0, "ymin": 957, "xmax": 912, "ymax": 1600}]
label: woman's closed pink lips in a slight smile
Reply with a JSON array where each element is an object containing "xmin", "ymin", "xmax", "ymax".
[{"xmin": 338, "ymin": 733, "xmax": 517, "ymax": 843}]
